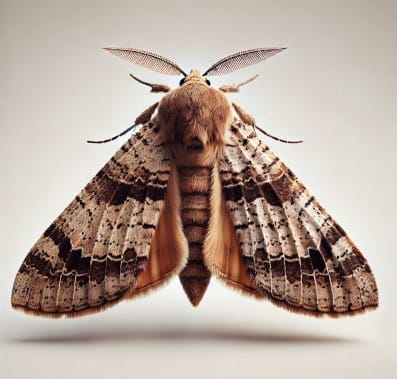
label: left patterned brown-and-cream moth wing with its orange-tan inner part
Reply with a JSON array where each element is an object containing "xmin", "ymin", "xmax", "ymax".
[{"xmin": 11, "ymin": 122, "xmax": 183, "ymax": 316}]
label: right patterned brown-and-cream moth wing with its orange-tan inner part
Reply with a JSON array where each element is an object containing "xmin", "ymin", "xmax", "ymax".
[{"xmin": 205, "ymin": 120, "xmax": 378, "ymax": 316}]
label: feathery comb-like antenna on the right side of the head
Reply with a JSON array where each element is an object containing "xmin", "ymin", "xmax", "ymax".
[{"xmin": 203, "ymin": 47, "xmax": 286, "ymax": 76}]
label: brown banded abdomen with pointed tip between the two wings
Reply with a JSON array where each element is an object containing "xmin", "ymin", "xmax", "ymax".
[{"xmin": 178, "ymin": 166, "xmax": 212, "ymax": 305}]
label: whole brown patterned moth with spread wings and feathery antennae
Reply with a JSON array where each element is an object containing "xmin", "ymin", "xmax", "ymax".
[{"xmin": 12, "ymin": 48, "xmax": 378, "ymax": 317}]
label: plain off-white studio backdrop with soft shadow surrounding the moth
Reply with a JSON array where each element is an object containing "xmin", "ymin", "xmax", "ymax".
[{"xmin": 0, "ymin": 0, "xmax": 397, "ymax": 378}]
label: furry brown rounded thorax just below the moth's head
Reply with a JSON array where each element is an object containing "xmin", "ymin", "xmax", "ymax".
[{"xmin": 158, "ymin": 81, "xmax": 232, "ymax": 162}]
